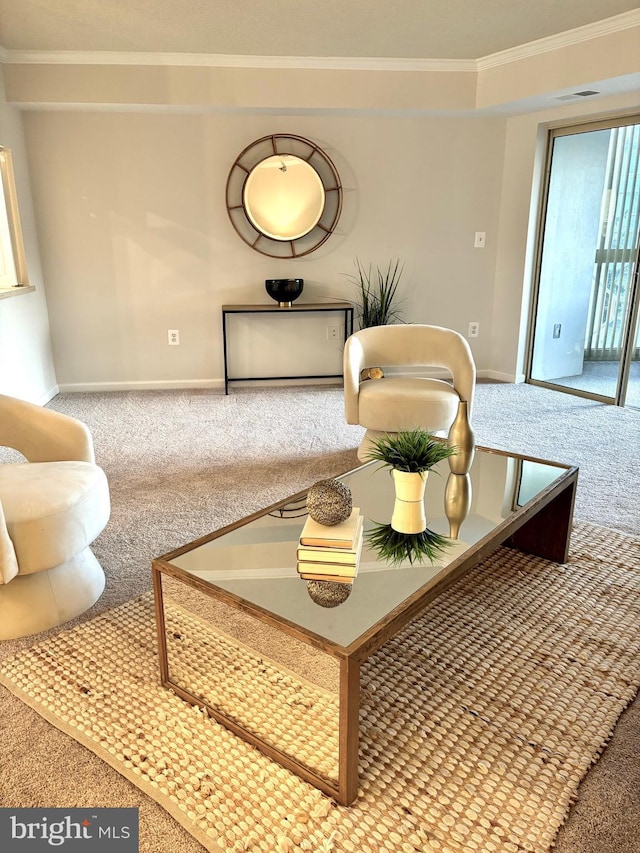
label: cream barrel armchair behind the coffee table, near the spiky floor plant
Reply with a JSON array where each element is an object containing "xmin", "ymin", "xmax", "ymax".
[{"xmin": 344, "ymin": 324, "xmax": 476, "ymax": 459}]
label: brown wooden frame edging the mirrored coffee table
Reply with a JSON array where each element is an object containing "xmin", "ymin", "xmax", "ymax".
[{"xmin": 152, "ymin": 448, "xmax": 578, "ymax": 806}]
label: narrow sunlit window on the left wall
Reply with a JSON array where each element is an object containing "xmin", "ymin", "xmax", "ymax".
[{"xmin": 0, "ymin": 146, "xmax": 29, "ymax": 289}]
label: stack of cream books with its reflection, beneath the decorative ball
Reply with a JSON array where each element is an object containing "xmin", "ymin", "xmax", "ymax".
[{"xmin": 298, "ymin": 507, "xmax": 364, "ymax": 583}]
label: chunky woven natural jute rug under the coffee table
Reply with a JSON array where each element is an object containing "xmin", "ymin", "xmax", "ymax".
[{"xmin": 0, "ymin": 524, "xmax": 640, "ymax": 853}]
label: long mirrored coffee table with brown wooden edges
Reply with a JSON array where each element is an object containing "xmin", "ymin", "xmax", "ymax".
[{"xmin": 152, "ymin": 448, "xmax": 578, "ymax": 805}]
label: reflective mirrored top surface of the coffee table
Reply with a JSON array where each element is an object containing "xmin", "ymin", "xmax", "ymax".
[{"xmin": 172, "ymin": 448, "xmax": 566, "ymax": 646}]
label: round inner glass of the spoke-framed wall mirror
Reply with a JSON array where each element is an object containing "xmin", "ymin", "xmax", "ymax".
[{"xmin": 243, "ymin": 154, "xmax": 325, "ymax": 240}]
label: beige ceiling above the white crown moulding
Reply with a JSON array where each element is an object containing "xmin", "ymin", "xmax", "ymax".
[{"xmin": 0, "ymin": 0, "xmax": 640, "ymax": 60}]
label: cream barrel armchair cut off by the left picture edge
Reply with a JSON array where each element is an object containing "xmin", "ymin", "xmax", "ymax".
[{"xmin": 0, "ymin": 395, "xmax": 110, "ymax": 640}]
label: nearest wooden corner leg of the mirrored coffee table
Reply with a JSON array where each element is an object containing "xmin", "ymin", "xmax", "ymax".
[{"xmin": 338, "ymin": 658, "xmax": 360, "ymax": 806}]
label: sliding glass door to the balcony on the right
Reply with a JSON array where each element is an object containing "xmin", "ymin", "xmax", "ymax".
[{"xmin": 528, "ymin": 117, "xmax": 640, "ymax": 407}]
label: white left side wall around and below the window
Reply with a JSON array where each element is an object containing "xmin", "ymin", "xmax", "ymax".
[{"xmin": 0, "ymin": 65, "xmax": 58, "ymax": 403}]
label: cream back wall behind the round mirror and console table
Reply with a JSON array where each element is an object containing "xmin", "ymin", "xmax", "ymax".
[{"xmin": 24, "ymin": 110, "xmax": 507, "ymax": 389}]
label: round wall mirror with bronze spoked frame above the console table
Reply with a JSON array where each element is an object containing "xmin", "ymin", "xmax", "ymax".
[{"xmin": 226, "ymin": 133, "xmax": 342, "ymax": 258}]
